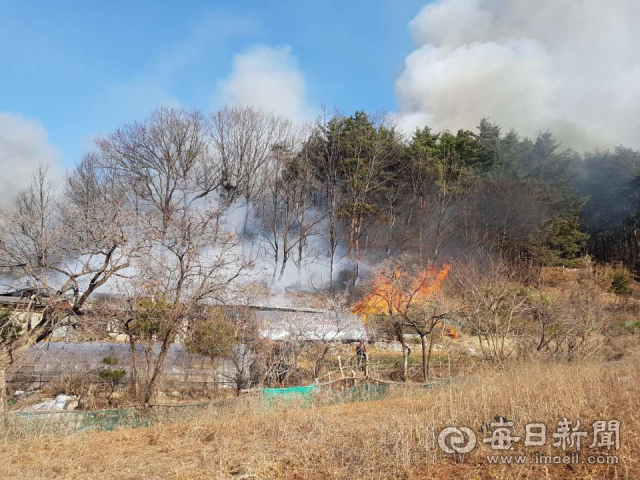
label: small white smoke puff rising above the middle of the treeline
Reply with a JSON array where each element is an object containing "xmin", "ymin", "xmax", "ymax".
[{"xmin": 217, "ymin": 45, "xmax": 315, "ymax": 123}]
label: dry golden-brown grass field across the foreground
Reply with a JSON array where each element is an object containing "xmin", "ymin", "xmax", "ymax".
[{"xmin": 0, "ymin": 359, "xmax": 640, "ymax": 480}]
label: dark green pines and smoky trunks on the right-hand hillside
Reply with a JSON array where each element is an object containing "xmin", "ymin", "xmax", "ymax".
[{"xmin": 200, "ymin": 110, "xmax": 640, "ymax": 287}]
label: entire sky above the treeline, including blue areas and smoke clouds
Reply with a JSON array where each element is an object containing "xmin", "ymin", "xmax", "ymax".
[{"xmin": 0, "ymin": 0, "xmax": 640, "ymax": 205}]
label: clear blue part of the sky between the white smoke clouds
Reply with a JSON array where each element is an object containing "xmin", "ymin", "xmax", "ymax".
[{"xmin": 0, "ymin": 0, "xmax": 426, "ymax": 166}]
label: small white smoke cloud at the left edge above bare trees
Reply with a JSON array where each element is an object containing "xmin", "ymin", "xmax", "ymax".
[{"xmin": 0, "ymin": 112, "xmax": 61, "ymax": 207}]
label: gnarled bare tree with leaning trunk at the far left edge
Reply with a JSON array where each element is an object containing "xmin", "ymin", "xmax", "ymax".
[{"xmin": 0, "ymin": 161, "xmax": 137, "ymax": 364}]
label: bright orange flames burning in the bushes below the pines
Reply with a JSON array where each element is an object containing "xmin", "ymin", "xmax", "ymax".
[{"xmin": 353, "ymin": 264, "xmax": 457, "ymax": 322}]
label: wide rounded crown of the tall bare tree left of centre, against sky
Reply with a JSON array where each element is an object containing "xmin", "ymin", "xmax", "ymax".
[{"xmin": 96, "ymin": 107, "xmax": 218, "ymax": 228}]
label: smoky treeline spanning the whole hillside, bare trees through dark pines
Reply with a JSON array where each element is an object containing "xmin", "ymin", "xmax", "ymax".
[{"xmin": 0, "ymin": 108, "xmax": 640, "ymax": 291}]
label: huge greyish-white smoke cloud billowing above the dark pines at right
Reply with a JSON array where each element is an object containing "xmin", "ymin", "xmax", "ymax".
[{"xmin": 396, "ymin": 0, "xmax": 640, "ymax": 148}]
